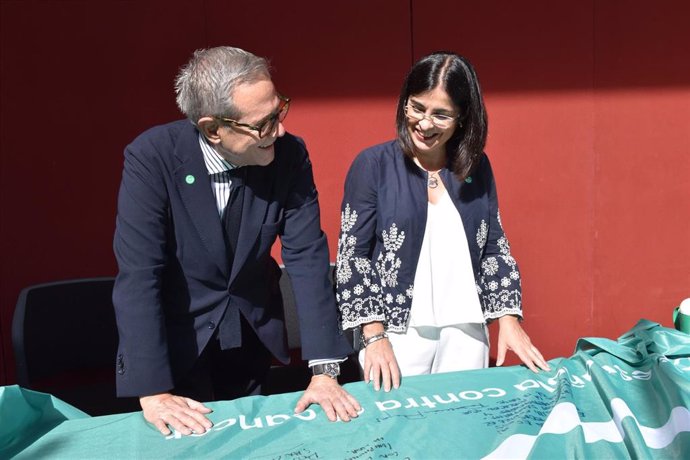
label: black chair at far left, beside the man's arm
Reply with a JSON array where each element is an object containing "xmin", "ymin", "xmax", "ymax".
[{"xmin": 12, "ymin": 277, "xmax": 141, "ymax": 416}]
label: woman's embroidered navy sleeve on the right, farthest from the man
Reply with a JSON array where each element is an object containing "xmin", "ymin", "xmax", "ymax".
[{"xmin": 477, "ymin": 156, "xmax": 522, "ymax": 322}]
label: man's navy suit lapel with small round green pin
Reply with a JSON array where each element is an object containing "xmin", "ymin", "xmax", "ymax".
[{"xmin": 174, "ymin": 124, "xmax": 228, "ymax": 277}]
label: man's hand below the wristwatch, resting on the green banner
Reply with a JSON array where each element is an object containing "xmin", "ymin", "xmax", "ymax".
[{"xmin": 295, "ymin": 375, "xmax": 362, "ymax": 422}]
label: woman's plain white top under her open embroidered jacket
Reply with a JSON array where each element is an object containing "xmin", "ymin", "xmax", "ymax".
[{"xmin": 410, "ymin": 192, "xmax": 484, "ymax": 327}]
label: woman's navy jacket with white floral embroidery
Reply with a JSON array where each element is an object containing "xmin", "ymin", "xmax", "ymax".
[{"xmin": 336, "ymin": 141, "xmax": 522, "ymax": 332}]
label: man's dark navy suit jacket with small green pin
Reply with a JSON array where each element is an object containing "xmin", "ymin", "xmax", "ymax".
[{"xmin": 113, "ymin": 120, "xmax": 352, "ymax": 396}]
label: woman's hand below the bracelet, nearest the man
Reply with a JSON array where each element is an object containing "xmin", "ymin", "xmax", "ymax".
[{"xmin": 362, "ymin": 322, "xmax": 400, "ymax": 392}]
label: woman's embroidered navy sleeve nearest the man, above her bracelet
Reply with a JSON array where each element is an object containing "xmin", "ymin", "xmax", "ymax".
[{"xmin": 336, "ymin": 152, "xmax": 386, "ymax": 329}]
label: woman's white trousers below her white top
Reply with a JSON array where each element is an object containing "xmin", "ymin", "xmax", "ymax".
[{"xmin": 359, "ymin": 323, "xmax": 489, "ymax": 377}]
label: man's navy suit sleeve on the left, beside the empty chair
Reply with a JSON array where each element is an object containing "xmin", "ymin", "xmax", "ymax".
[{"xmin": 113, "ymin": 143, "xmax": 174, "ymax": 396}]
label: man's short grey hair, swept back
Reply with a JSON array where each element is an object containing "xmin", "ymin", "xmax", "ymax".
[{"xmin": 175, "ymin": 46, "xmax": 271, "ymax": 124}]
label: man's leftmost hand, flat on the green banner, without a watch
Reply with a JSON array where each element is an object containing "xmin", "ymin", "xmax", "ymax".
[{"xmin": 139, "ymin": 393, "xmax": 213, "ymax": 436}]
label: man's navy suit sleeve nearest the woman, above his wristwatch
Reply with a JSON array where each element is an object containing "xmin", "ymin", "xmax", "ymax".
[{"xmin": 281, "ymin": 141, "xmax": 352, "ymax": 360}]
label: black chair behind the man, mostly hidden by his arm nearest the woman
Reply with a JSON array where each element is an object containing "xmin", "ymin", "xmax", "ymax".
[{"xmin": 264, "ymin": 264, "xmax": 361, "ymax": 395}]
